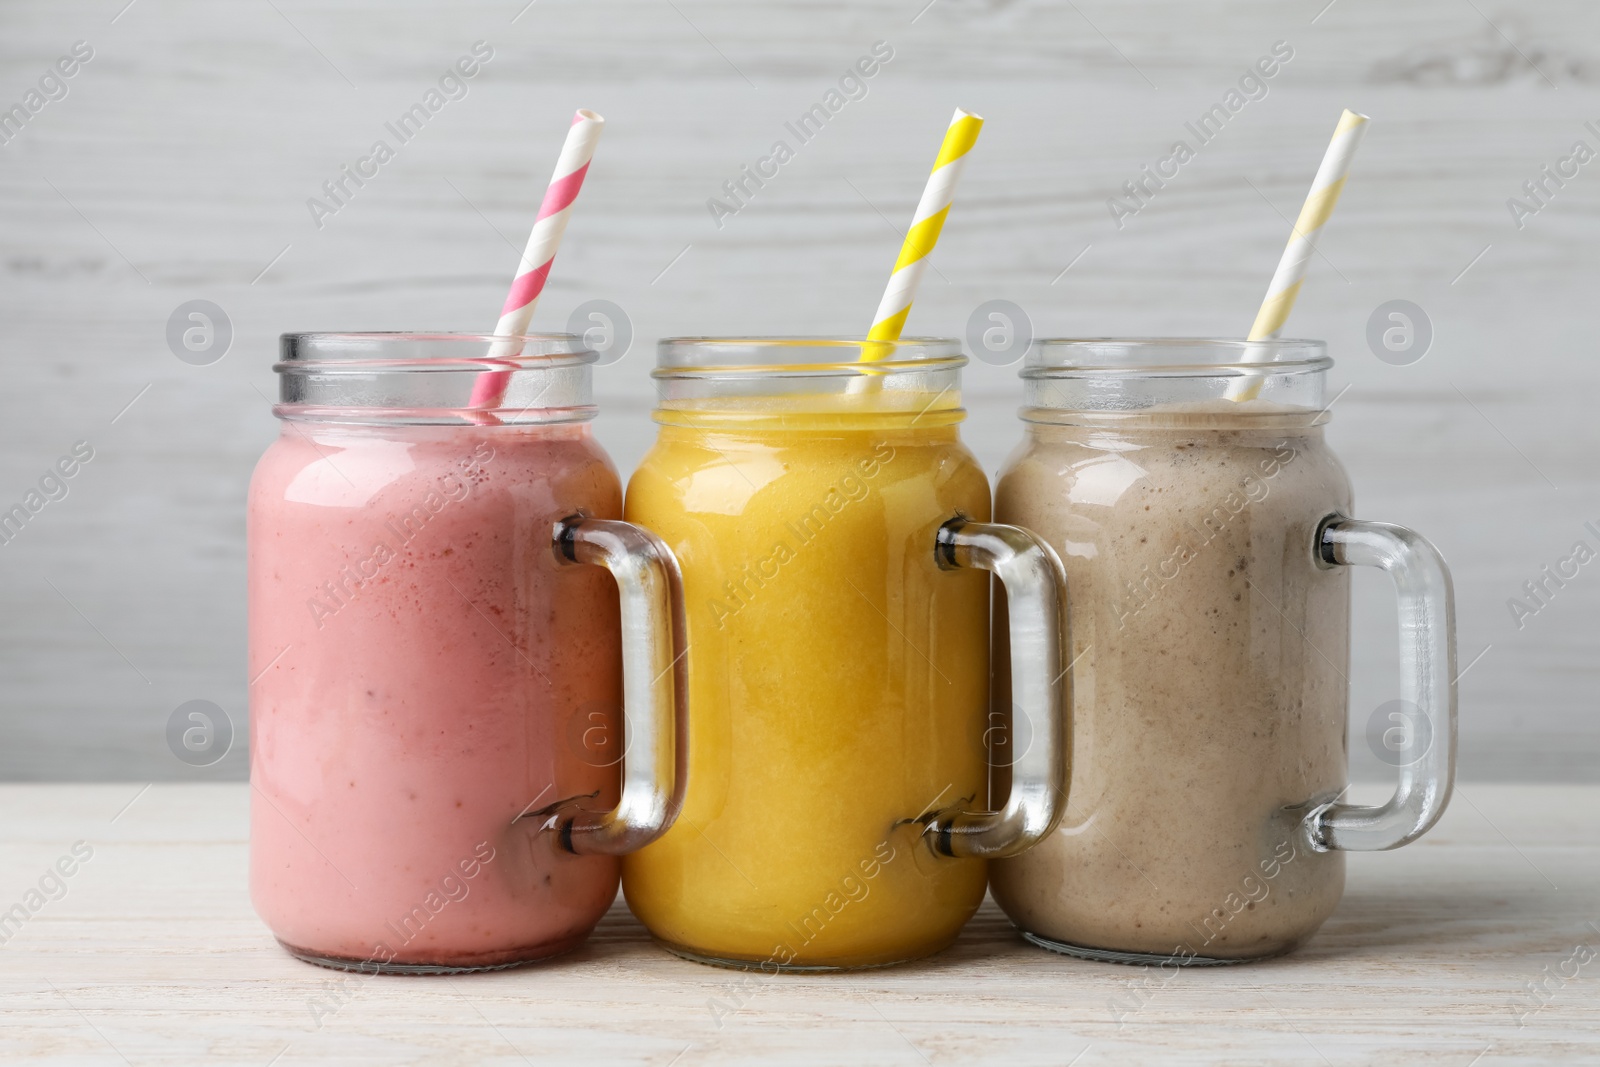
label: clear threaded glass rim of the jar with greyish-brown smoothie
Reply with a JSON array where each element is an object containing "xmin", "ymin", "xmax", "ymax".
[{"xmin": 1021, "ymin": 338, "xmax": 1333, "ymax": 378}]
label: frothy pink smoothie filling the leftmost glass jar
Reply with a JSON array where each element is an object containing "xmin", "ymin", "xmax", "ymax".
[{"xmin": 250, "ymin": 421, "xmax": 622, "ymax": 969}]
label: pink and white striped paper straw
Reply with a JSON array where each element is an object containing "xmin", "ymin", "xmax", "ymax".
[{"xmin": 467, "ymin": 109, "xmax": 605, "ymax": 418}]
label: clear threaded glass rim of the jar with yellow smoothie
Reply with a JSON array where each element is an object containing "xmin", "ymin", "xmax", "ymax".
[{"xmin": 651, "ymin": 334, "xmax": 966, "ymax": 379}]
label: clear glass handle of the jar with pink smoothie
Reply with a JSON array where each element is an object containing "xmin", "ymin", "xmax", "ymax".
[{"xmin": 552, "ymin": 515, "xmax": 690, "ymax": 856}]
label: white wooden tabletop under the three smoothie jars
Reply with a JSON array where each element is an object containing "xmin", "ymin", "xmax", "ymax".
[{"xmin": 0, "ymin": 782, "xmax": 1600, "ymax": 1067}]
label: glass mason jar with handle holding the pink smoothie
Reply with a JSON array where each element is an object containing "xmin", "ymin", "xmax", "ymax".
[{"xmin": 248, "ymin": 334, "xmax": 685, "ymax": 973}]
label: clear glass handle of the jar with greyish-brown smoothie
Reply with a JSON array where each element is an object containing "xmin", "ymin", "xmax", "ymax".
[{"xmin": 1304, "ymin": 515, "xmax": 1456, "ymax": 853}]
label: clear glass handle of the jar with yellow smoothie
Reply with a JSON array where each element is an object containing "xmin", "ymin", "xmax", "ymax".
[{"xmin": 925, "ymin": 518, "xmax": 1072, "ymax": 859}]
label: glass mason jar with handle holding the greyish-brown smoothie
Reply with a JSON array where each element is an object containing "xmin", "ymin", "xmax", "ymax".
[{"xmin": 992, "ymin": 339, "xmax": 1456, "ymax": 965}]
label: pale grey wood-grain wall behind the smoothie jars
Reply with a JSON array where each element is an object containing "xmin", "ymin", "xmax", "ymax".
[{"xmin": 0, "ymin": 0, "xmax": 1600, "ymax": 781}]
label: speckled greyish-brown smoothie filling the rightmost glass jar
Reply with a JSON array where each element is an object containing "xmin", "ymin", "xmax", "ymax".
[{"xmin": 990, "ymin": 402, "xmax": 1350, "ymax": 960}]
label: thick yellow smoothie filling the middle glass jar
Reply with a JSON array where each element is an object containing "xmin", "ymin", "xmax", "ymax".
[{"xmin": 622, "ymin": 390, "xmax": 989, "ymax": 971}]
